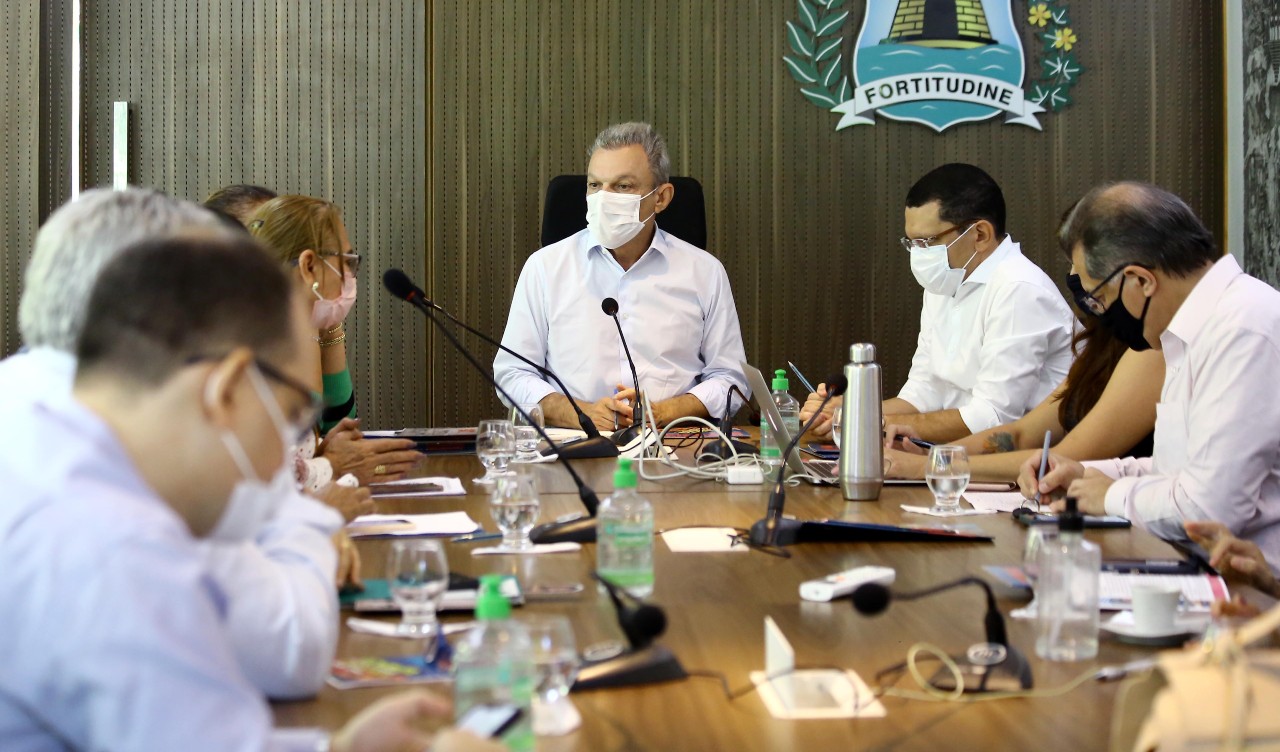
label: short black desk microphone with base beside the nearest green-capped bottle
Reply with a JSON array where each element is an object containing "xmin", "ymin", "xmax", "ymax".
[{"xmin": 573, "ymin": 572, "xmax": 689, "ymax": 692}]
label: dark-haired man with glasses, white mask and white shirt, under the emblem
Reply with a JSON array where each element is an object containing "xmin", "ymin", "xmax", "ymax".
[{"xmin": 800, "ymin": 164, "xmax": 1075, "ymax": 443}]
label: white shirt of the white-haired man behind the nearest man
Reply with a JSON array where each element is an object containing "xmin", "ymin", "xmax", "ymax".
[{"xmin": 0, "ymin": 348, "xmax": 343, "ymax": 700}]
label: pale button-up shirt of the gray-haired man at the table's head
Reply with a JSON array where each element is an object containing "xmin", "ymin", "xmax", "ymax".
[{"xmin": 493, "ymin": 229, "xmax": 750, "ymax": 417}]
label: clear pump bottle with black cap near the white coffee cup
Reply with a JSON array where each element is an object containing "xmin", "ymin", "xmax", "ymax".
[{"xmin": 1036, "ymin": 499, "xmax": 1102, "ymax": 661}]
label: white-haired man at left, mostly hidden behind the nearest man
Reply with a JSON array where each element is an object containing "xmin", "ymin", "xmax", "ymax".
[{"xmin": 0, "ymin": 188, "xmax": 350, "ymax": 698}]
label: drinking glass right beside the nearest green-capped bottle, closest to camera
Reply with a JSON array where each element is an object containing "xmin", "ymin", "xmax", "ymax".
[{"xmin": 521, "ymin": 615, "xmax": 579, "ymax": 735}]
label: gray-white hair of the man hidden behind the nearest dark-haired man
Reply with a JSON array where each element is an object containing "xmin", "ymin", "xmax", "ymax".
[{"xmin": 18, "ymin": 188, "xmax": 228, "ymax": 353}]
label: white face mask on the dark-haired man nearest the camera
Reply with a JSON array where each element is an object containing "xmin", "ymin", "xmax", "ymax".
[{"xmin": 209, "ymin": 366, "xmax": 297, "ymax": 542}]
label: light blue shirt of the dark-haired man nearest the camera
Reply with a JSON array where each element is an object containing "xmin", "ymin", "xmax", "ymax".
[{"xmin": 0, "ymin": 396, "xmax": 323, "ymax": 752}]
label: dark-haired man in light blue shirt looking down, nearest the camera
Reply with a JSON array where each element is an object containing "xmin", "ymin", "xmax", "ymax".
[{"xmin": 0, "ymin": 234, "xmax": 494, "ymax": 752}]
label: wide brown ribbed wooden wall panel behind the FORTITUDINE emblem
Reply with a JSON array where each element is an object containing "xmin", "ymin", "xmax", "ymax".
[{"xmin": 430, "ymin": 0, "xmax": 1224, "ymax": 425}]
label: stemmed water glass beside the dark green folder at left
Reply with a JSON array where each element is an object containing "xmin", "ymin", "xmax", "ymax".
[{"xmin": 387, "ymin": 538, "xmax": 449, "ymax": 661}]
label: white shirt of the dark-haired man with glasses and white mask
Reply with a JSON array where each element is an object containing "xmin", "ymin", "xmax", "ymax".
[{"xmin": 897, "ymin": 235, "xmax": 1075, "ymax": 434}]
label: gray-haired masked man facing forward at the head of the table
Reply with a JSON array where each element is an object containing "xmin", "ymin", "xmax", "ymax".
[{"xmin": 493, "ymin": 123, "xmax": 749, "ymax": 430}]
